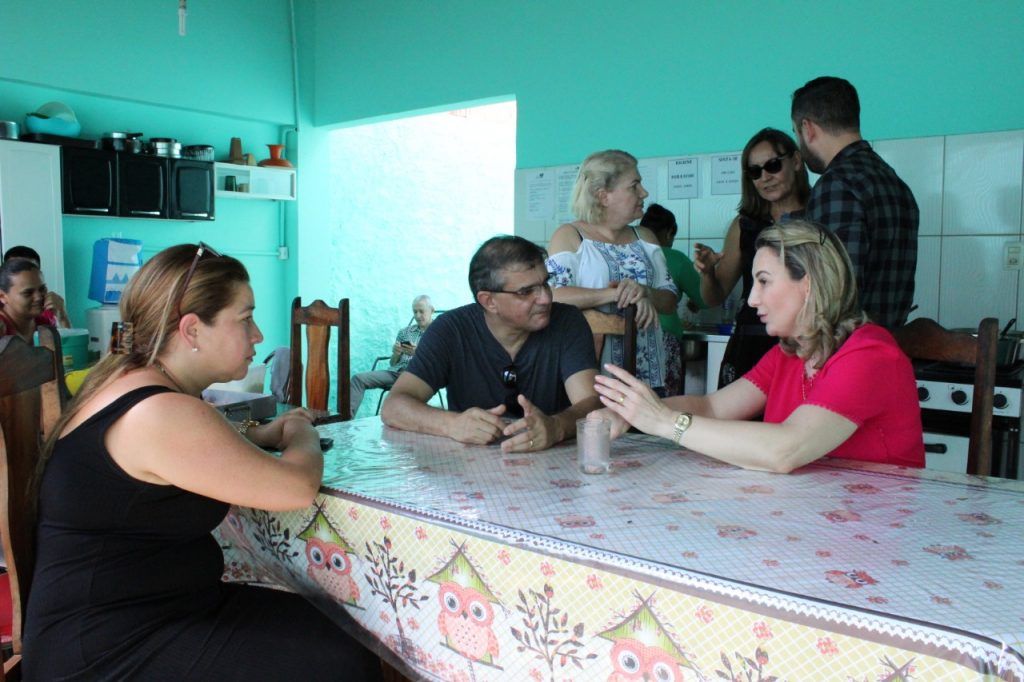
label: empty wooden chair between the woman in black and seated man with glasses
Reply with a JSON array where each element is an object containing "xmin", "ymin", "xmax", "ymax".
[{"xmin": 288, "ymin": 296, "xmax": 351, "ymax": 423}]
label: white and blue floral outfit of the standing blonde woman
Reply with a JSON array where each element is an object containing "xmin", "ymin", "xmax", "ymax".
[{"xmin": 547, "ymin": 230, "xmax": 679, "ymax": 388}]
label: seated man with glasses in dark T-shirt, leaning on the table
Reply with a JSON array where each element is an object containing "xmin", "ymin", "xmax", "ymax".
[{"xmin": 381, "ymin": 236, "xmax": 600, "ymax": 452}]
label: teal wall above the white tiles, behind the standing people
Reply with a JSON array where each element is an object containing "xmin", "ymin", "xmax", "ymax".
[{"xmin": 313, "ymin": 0, "xmax": 1024, "ymax": 168}]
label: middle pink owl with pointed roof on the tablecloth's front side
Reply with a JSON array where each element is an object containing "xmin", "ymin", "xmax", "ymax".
[{"xmin": 427, "ymin": 543, "xmax": 501, "ymax": 666}]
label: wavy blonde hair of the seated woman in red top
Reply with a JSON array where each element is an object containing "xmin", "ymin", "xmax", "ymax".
[{"xmin": 756, "ymin": 220, "xmax": 867, "ymax": 368}]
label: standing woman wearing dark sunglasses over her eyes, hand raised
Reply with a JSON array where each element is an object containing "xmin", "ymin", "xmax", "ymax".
[{"xmin": 693, "ymin": 128, "xmax": 811, "ymax": 385}]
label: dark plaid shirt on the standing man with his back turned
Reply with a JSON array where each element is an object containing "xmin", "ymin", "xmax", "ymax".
[{"xmin": 806, "ymin": 140, "xmax": 920, "ymax": 328}]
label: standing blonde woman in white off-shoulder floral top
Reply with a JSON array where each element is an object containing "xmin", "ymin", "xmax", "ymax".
[{"xmin": 548, "ymin": 150, "xmax": 679, "ymax": 390}]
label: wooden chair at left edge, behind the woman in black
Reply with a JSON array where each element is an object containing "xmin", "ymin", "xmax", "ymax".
[{"xmin": 0, "ymin": 332, "xmax": 63, "ymax": 679}]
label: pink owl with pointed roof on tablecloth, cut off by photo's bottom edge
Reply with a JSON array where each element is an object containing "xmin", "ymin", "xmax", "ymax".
[{"xmin": 598, "ymin": 594, "xmax": 697, "ymax": 682}]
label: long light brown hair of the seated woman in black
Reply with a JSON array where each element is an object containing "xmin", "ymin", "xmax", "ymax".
[{"xmin": 40, "ymin": 244, "xmax": 249, "ymax": 466}]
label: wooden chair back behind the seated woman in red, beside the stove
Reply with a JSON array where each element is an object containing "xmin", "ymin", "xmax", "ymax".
[{"xmin": 893, "ymin": 317, "xmax": 999, "ymax": 476}]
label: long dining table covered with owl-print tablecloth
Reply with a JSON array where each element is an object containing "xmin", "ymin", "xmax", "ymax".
[{"xmin": 216, "ymin": 418, "xmax": 1024, "ymax": 682}]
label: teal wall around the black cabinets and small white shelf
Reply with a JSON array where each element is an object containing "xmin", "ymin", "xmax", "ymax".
[{"xmin": 0, "ymin": 0, "xmax": 297, "ymax": 353}]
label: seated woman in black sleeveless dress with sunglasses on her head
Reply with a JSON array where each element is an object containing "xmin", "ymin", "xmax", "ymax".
[{"xmin": 24, "ymin": 244, "xmax": 380, "ymax": 680}]
